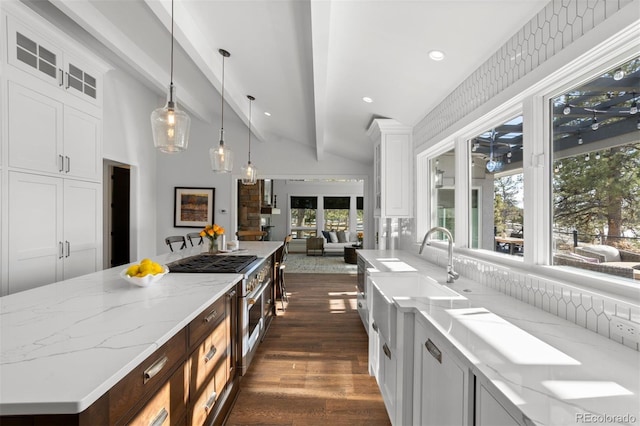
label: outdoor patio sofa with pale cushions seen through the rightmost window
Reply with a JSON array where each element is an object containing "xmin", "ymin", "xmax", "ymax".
[{"xmin": 553, "ymin": 245, "xmax": 640, "ymax": 280}]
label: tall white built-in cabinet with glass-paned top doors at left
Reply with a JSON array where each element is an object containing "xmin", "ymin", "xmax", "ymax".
[{"xmin": 0, "ymin": 2, "xmax": 107, "ymax": 295}]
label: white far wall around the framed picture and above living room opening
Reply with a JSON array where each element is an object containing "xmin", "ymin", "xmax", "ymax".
[{"xmin": 155, "ymin": 103, "xmax": 373, "ymax": 253}]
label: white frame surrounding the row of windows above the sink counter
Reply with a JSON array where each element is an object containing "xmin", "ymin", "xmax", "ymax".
[{"xmin": 415, "ymin": 40, "xmax": 640, "ymax": 299}]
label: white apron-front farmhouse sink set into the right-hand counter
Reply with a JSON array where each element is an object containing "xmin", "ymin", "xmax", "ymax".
[{"xmin": 371, "ymin": 274, "xmax": 469, "ymax": 345}]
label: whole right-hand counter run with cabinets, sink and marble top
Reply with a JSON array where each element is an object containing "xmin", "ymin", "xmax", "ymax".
[{"xmin": 358, "ymin": 249, "xmax": 640, "ymax": 426}]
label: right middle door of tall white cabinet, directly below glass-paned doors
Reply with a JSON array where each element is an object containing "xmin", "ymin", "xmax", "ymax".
[{"xmin": 64, "ymin": 106, "xmax": 102, "ymax": 180}]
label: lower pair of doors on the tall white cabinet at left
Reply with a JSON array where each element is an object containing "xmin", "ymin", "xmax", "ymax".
[{"xmin": 8, "ymin": 172, "xmax": 102, "ymax": 293}]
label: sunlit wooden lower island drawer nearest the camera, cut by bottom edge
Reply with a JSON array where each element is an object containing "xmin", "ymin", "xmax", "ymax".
[{"xmin": 127, "ymin": 364, "xmax": 188, "ymax": 426}]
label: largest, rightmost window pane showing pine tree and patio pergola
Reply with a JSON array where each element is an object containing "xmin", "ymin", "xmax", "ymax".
[{"xmin": 551, "ymin": 58, "xmax": 640, "ymax": 278}]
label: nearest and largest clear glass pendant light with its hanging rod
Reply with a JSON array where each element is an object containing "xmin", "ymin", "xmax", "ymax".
[{"xmin": 151, "ymin": 0, "xmax": 191, "ymax": 154}]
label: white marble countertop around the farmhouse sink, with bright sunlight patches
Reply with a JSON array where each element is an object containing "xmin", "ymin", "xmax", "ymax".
[{"xmin": 359, "ymin": 250, "xmax": 640, "ymax": 425}]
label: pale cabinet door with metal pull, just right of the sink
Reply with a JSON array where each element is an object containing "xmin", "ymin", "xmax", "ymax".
[{"xmin": 413, "ymin": 315, "xmax": 472, "ymax": 426}]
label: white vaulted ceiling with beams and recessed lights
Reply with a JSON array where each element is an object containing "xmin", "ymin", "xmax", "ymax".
[{"xmin": 50, "ymin": 0, "xmax": 547, "ymax": 164}]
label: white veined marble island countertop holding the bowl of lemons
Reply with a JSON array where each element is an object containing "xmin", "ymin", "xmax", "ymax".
[{"xmin": 0, "ymin": 241, "xmax": 282, "ymax": 415}]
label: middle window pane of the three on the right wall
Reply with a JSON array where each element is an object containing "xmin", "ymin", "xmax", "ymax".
[{"xmin": 469, "ymin": 116, "xmax": 525, "ymax": 256}]
